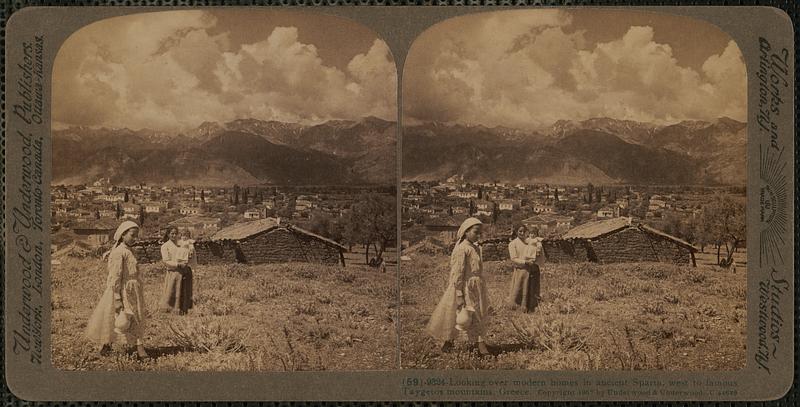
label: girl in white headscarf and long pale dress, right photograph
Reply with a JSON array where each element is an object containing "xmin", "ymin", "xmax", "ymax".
[{"xmin": 427, "ymin": 218, "xmax": 489, "ymax": 355}]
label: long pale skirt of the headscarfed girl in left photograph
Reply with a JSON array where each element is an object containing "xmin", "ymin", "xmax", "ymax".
[{"xmin": 86, "ymin": 280, "xmax": 147, "ymax": 345}]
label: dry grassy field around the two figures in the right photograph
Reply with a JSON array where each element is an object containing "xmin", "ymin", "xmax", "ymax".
[{"xmin": 400, "ymin": 255, "xmax": 747, "ymax": 371}]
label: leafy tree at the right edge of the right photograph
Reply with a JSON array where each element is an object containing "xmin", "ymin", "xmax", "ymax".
[{"xmin": 702, "ymin": 195, "xmax": 746, "ymax": 267}]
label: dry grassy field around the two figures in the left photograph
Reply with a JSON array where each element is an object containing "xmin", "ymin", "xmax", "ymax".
[{"xmin": 52, "ymin": 258, "xmax": 397, "ymax": 371}]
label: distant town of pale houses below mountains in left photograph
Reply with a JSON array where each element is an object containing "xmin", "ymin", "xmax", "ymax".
[{"xmin": 51, "ymin": 178, "xmax": 396, "ymax": 249}]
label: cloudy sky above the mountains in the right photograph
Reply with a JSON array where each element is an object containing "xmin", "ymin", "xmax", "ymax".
[{"xmin": 403, "ymin": 9, "xmax": 747, "ymax": 128}]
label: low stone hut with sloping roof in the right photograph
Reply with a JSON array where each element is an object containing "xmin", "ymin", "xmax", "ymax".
[{"xmin": 543, "ymin": 217, "xmax": 697, "ymax": 266}]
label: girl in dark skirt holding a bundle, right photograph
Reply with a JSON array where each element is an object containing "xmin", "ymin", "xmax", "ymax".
[{"xmin": 508, "ymin": 225, "xmax": 541, "ymax": 312}]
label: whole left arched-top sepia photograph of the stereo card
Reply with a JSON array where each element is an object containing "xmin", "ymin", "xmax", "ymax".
[{"xmin": 51, "ymin": 10, "xmax": 398, "ymax": 371}]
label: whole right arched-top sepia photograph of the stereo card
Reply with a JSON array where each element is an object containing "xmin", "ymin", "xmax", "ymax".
[{"xmin": 400, "ymin": 9, "xmax": 747, "ymax": 371}]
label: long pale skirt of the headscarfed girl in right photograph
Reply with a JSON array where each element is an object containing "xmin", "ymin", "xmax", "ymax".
[{"xmin": 426, "ymin": 276, "xmax": 489, "ymax": 342}]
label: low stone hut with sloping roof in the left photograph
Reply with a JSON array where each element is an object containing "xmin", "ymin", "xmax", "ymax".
[{"xmin": 203, "ymin": 218, "xmax": 347, "ymax": 265}]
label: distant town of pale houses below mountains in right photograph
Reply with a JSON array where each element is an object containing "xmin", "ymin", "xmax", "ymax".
[{"xmin": 402, "ymin": 178, "xmax": 745, "ymax": 252}]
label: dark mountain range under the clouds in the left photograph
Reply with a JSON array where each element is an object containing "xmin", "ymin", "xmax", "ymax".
[{"xmin": 52, "ymin": 117, "xmax": 396, "ymax": 186}]
